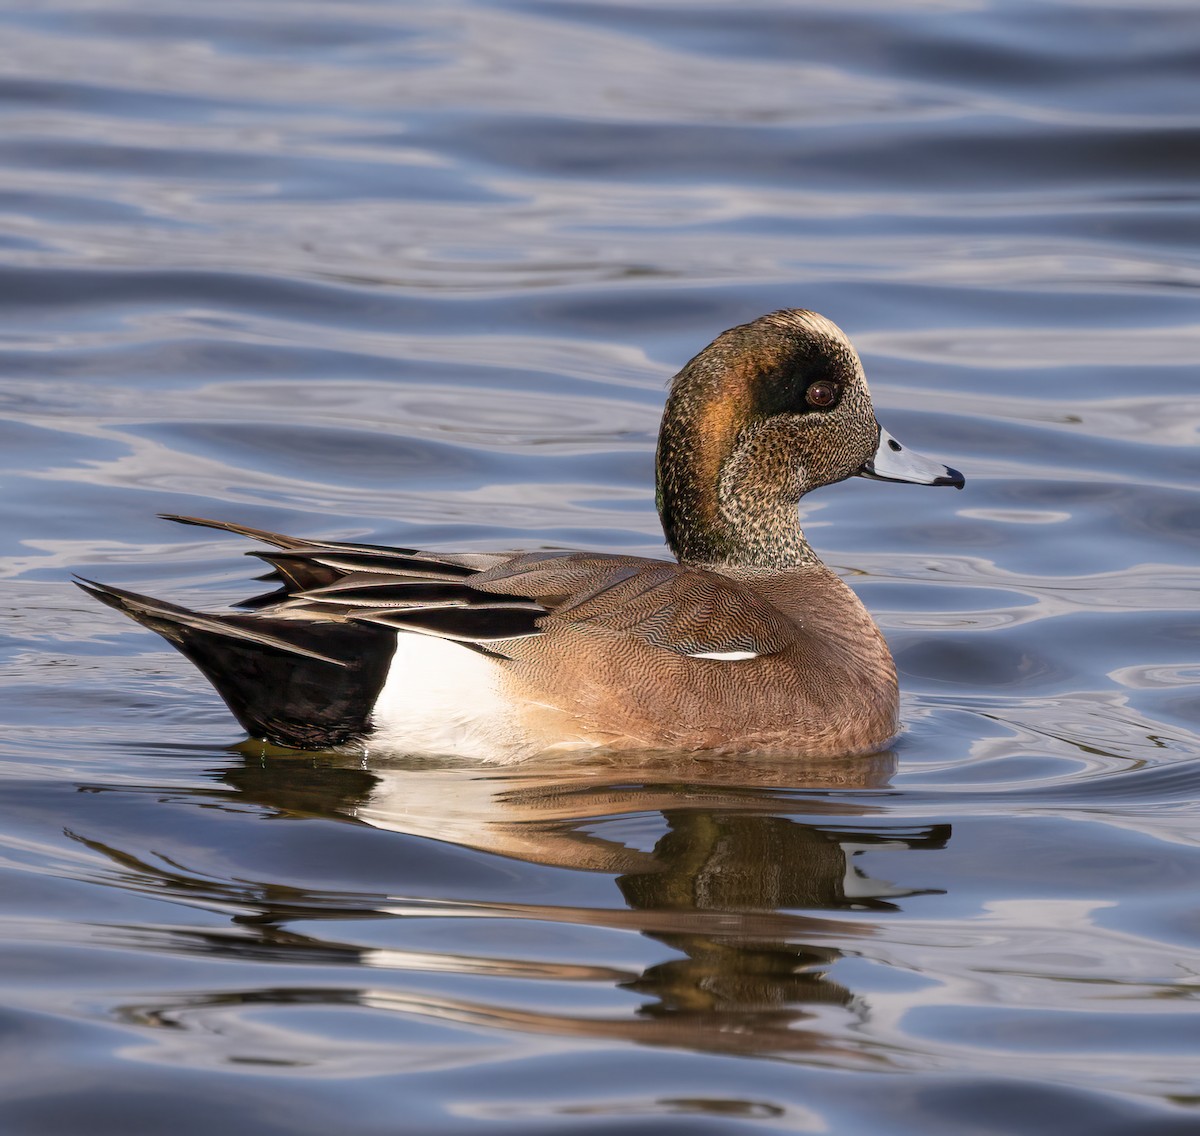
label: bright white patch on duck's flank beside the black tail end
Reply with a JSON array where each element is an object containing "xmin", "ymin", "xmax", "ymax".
[{"xmin": 368, "ymin": 631, "xmax": 523, "ymax": 761}]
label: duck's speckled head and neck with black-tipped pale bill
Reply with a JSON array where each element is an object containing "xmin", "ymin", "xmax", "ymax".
[{"xmin": 658, "ymin": 309, "xmax": 962, "ymax": 567}]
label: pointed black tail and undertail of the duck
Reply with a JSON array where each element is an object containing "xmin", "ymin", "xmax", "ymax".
[{"xmin": 76, "ymin": 579, "xmax": 396, "ymax": 750}]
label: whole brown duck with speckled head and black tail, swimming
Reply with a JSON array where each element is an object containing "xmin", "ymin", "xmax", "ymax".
[{"xmin": 76, "ymin": 308, "xmax": 964, "ymax": 762}]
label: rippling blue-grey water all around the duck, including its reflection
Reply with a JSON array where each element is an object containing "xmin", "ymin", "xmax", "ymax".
[{"xmin": 0, "ymin": 0, "xmax": 1200, "ymax": 1136}]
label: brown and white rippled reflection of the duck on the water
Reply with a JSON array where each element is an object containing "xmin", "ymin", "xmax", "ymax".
[{"xmin": 91, "ymin": 753, "xmax": 949, "ymax": 1053}]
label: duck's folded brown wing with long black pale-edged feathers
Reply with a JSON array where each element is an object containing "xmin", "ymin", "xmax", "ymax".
[{"xmin": 157, "ymin": 517, "xmax": 797, "ymax": 662}]
